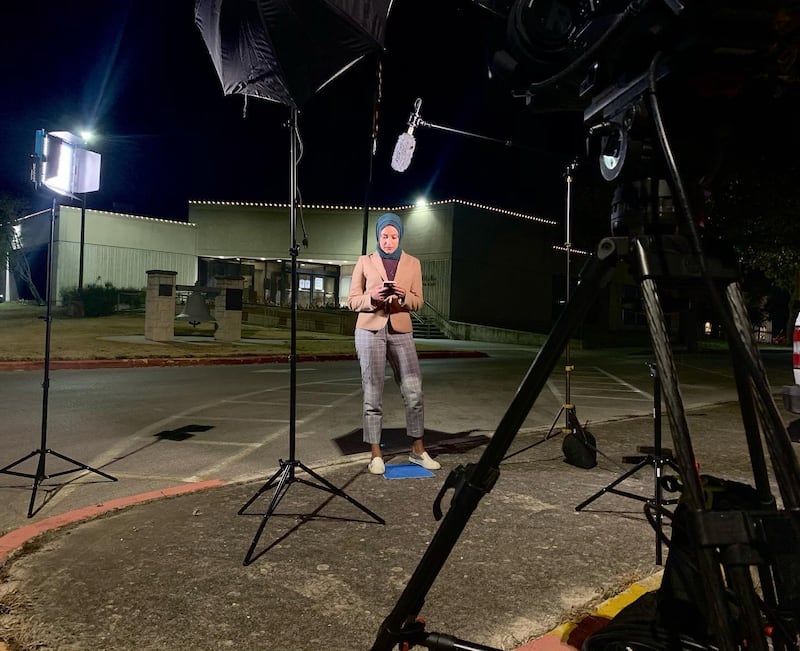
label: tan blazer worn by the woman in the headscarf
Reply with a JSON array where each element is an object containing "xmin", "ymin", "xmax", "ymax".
[{"xmin": 347, "ymin": 251, "xmax": 423, "ymax": 332}]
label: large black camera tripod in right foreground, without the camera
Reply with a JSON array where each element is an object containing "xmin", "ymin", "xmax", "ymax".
[{"xmin": 372, "ymin": 55, "xmax": 800, "ymax": 651}]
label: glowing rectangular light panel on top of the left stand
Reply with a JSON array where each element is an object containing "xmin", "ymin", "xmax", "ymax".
[{"xmin": 34, "ymin": 129, "xmax": 100, "ymax": 196}]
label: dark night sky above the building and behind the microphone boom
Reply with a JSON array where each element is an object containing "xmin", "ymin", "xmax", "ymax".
[{"xmin": 0, "ymin": 0, "xmax": 578, "ymax": 224}]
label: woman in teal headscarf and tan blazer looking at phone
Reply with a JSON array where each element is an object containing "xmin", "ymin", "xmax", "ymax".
[{"xmin": 347, "ymin": 213, "xmax": 441, "ymax": 475}]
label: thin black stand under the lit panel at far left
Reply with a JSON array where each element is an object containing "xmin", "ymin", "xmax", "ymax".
[{"xmin": 0, "ymin": 198, "xmax": 117, "ymax": 518}]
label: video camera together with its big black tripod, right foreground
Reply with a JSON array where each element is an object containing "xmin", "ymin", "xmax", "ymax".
[{"xmin": 372, "ymin": 0, "xmax": 800, "ymax": 651}]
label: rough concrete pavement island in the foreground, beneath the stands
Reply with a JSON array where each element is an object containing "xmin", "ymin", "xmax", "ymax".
[{"xmin": 0, "ymin": 404, "xmax": 792, "ymax": 651}]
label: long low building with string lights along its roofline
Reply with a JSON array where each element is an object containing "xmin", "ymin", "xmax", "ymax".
[{"xmin": 10, "ymin": 200, "xmax": 564, "ymax": 332}]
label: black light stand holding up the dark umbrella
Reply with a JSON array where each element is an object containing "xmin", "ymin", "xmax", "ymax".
[{"xmin": 239, "ymin": 107, "xmax": 386, "ymax": 565}]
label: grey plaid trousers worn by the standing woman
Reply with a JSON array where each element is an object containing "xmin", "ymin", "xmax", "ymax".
[{"xmin": 355, "ymin": 325, "xmax": 425, "ymax": 444}]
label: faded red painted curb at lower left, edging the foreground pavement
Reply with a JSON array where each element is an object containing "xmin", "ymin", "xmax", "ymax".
[{"xmin": 0, "ymin": 479, "xmax": 225, "ymax": 562}]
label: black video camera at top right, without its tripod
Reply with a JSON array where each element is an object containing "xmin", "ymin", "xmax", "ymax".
[{"xmin": 484, "ymin": 0, "xmax": 780, "ymax": 118}]
